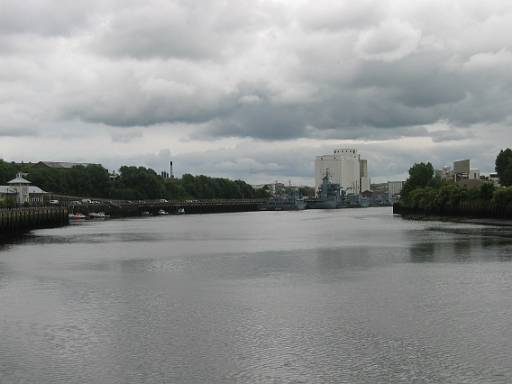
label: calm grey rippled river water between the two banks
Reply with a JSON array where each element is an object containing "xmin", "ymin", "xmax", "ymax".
[{"xmin": 0, "ymin": 208, "xmax": 512, "ymax": 384}]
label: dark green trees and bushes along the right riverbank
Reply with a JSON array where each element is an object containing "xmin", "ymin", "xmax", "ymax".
[{"xmin": 400, "ymin": 148, "xmax": 512, "ymax": 213}]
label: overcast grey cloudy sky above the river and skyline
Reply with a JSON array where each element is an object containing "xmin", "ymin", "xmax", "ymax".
[{"xmin": 0, "ymin": 0, "xmax": 512, "ymax": 184}]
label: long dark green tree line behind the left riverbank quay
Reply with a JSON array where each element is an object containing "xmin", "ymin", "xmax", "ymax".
[{"xmin": 0, "ymin": 160, "xmax": 269, "ymax": 200}]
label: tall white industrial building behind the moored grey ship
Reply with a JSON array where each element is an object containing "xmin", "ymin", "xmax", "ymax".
[{"xmin": 315, "ymin": 148, "xmax": 370, "ymax": 194}]
